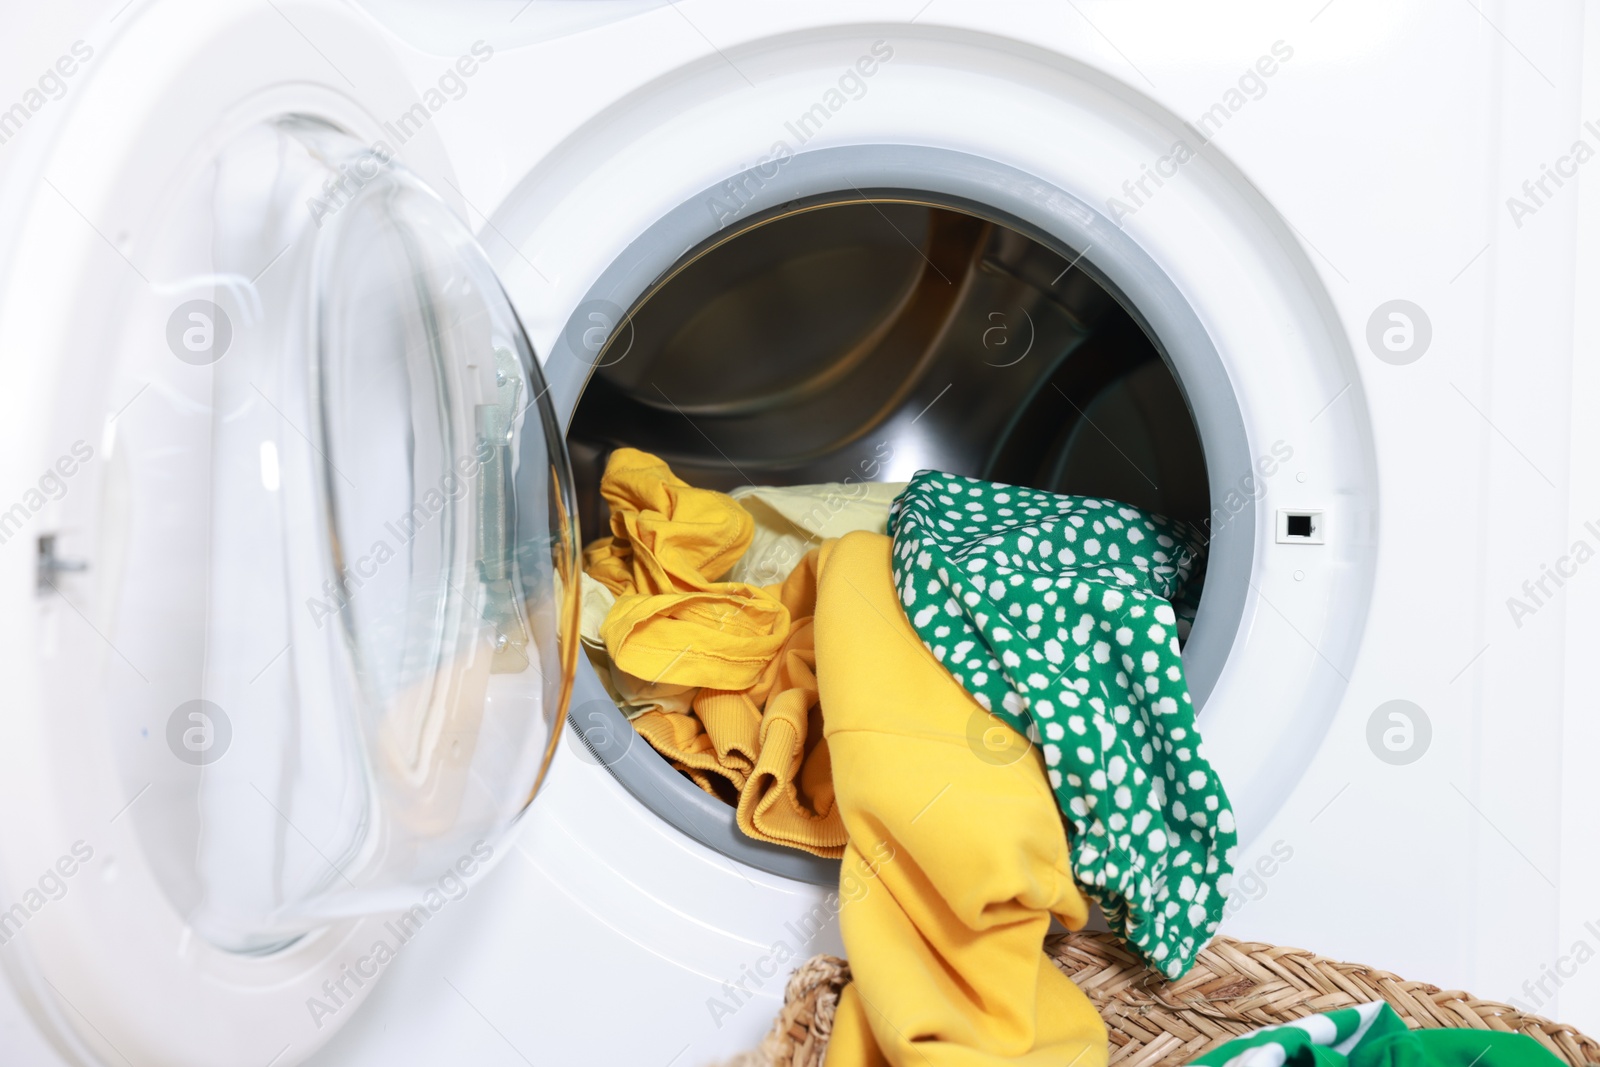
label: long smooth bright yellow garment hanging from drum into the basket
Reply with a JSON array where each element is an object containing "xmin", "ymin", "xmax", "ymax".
[{"xmin": 814, "ymin": 533, "xmax": 1107, "ymax": 1067}]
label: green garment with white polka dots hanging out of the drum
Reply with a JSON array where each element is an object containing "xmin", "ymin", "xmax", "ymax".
[{"xmin": 890, "ymin": 470, "xmax": 1237, "ymax": 977}]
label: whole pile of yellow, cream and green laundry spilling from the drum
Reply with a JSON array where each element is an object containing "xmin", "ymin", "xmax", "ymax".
[{"xmin": 582, "ymin": 448, "xmax": 1235, "ymax": 1067}]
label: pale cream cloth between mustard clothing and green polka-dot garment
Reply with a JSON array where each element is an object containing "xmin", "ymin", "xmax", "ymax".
[{"xmin": 728, "ymin": 482, "xmax": 906, "ymax": 585}]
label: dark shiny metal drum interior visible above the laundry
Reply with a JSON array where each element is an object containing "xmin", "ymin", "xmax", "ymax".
[{"xmin": 568, "ymin": 197, "xmax": 1210, "ymax": 537}]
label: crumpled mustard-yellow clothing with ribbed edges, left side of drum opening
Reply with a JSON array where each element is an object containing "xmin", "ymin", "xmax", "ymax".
[{"xmin": 584, "ymin": 448, "xmax": 845, "ymax": 857}]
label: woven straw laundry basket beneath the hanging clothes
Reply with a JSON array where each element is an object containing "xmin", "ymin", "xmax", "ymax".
[{"xmin": 726, "ymin": 933, "xmax": 1600, "ymax": 1067}]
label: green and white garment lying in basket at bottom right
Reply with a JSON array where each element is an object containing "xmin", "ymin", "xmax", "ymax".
[{"xmin": 1195, "ymin": 1000, "xmax": 1566, "ymax": 1067}]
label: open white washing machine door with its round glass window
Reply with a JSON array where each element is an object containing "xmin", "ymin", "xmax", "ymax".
[{"xmin": 0, "ymin": 0, "xmax": 578, "ymax": 1067}]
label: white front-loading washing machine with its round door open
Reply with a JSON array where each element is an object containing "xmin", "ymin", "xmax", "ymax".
[{"xmin": 0, "ymin": 0, "xmax": 1600, "ymax": 1067}]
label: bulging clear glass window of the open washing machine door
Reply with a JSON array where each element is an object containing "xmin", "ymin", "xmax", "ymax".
[{"xmin": 86, "ymin": 118, "xmax": 578, "ymax": 952}]
